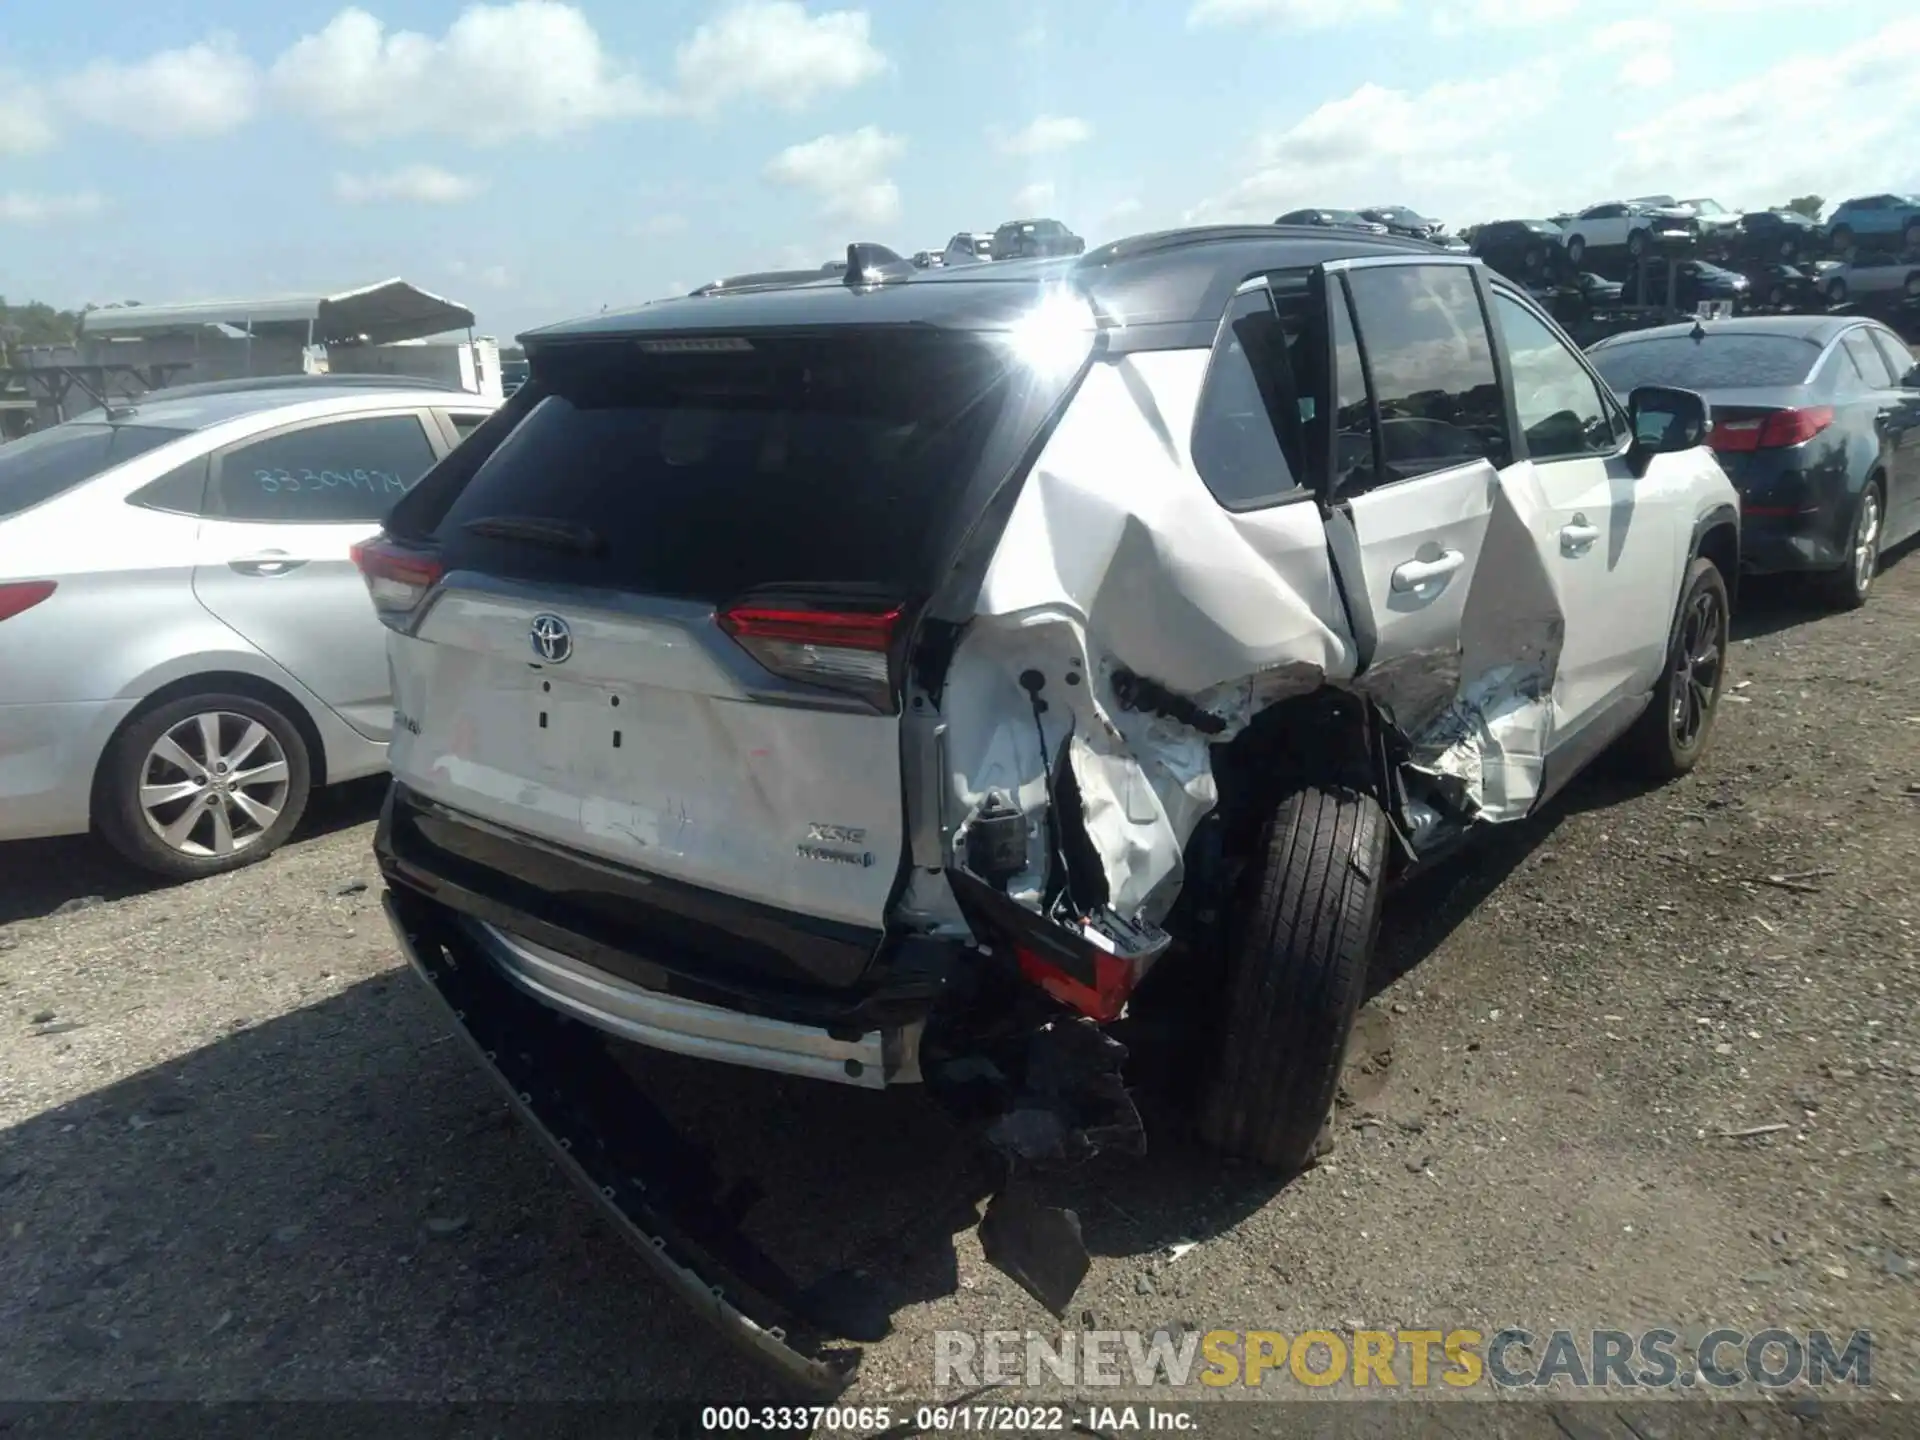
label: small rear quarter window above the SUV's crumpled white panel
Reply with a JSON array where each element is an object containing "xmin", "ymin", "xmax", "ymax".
[{"xmin": 1192, "ymin": 290, "xmax": 1304, "ymax": 511}]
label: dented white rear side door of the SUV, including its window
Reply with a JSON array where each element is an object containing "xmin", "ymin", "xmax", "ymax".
[{"xmin": 1325, "ymin": 257, "xmax": 1563, "ymax": 818}]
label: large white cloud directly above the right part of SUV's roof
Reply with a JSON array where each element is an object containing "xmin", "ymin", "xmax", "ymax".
[{"xmin": 1187, "ymin": 58, "xmax": 1559, "ymax": 221}]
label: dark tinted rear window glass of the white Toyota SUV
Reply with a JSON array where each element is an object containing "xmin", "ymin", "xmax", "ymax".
[{"xmin": 434, "ymin": 334, "xmax": 1010, "ymax": 603}]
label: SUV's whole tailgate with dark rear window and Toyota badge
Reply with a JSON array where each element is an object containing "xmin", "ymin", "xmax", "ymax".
[{"xmin": 392, "ymin": 330, "xmax": 1029, "ymax": 931}]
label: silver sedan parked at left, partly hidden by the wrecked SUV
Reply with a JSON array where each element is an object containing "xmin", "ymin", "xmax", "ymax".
[{"xmin": 0, "ymin": 378, "xmax": 495, "ymax": 879}]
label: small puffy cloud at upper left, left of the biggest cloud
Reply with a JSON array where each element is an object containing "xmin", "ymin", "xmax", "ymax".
[{"xmin": 60, "ymin": 35, "xmax": 259, "ymax": 138}]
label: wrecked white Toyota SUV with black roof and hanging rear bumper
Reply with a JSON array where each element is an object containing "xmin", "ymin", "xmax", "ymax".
[{"xmin": 359, "ymin": 227, "xmax": 1740, "ymax": 1382}]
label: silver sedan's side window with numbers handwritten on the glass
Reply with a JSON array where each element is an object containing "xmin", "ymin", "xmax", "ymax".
[{"xmin": 219, "ymin": 415, "xmax": 434, "ymax": 524}]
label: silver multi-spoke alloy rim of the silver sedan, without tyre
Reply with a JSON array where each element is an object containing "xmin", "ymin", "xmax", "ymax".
[{"xmin": 140, "ymin": 710, "xmax": 292, "ymax": 858}]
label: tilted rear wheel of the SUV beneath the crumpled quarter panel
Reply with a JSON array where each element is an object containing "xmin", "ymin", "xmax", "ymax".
[{"xmin": 1200, "ymin": 789, "xmax": 1386, "ymax": 1175}]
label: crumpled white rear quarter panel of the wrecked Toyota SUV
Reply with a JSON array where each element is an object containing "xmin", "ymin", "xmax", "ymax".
[{"xmin": 943, "ymin": 349, "xmax": 1356, "ymax": 924}]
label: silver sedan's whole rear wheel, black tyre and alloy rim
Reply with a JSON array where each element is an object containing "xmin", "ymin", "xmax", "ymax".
[{"xmin": 94, "ymin": 693, "xmax": 311, "ymax": 879}]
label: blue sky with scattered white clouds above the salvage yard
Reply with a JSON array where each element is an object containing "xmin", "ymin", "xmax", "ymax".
[{"xmin": 0, "ymin": 0, "xmax": 1920, "ymax": 338}]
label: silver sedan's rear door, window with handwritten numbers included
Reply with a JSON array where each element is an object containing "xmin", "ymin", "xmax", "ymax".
[{"xmin": 194, "ymin": 409, "xmax": 444, "ymax": 741}]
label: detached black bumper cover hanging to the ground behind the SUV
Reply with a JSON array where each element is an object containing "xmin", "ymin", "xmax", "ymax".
[{"xmin": 386, "ymin": 891, "xmax": 854, "ymax": 1394}]
